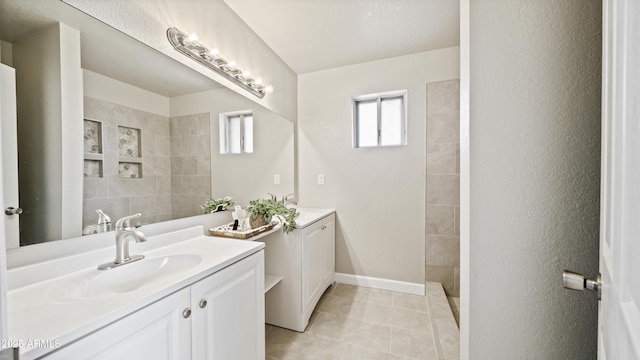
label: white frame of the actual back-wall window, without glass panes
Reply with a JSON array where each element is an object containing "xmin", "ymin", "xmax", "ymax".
[{"xmin": 351, "ymin": 90, "xmax": 408, "ymax": 149}]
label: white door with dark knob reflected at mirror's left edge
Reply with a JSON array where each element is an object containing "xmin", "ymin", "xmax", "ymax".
[{"xmin": 0, "ymin": 64, "xmax": 20, "ymax": 249}]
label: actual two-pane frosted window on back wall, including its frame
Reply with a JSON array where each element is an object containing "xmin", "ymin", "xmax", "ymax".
[{"xmin": 353, "ymin": 91, "xmax": 407, "ymax": 148}]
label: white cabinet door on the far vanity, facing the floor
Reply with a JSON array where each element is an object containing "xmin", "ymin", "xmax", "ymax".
[{"xmin": 302, "ymin": 214, "xmax": 335, "ymax": 320}]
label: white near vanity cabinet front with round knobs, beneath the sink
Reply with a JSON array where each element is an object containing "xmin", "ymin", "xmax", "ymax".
[{"xmin": 44, "ymin": 251, "xmax": 265, "ymax": 360}]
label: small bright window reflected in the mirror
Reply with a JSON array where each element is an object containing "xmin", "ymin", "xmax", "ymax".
[{"xmin": 219, "ymin": 111, "xmax": 253, "ymax": 154}]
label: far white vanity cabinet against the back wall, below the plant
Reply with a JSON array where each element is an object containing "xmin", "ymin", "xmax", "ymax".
[{"xmin": 262, "ymin": 210, "xmax": 336, "ymax": 332}]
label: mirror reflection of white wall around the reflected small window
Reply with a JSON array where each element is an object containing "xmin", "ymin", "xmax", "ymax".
[{"xmin": 171, "ymin": 88, "xmax": 295, "ymax": 206}]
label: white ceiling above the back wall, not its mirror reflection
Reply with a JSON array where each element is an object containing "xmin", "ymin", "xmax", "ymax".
[{"xmin": 224, "ymin": 0, "xmax": 460, "ymax": 74}]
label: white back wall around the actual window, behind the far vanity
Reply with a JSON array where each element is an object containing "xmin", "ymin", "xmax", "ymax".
[{"xmin": 297, "ymin": 47, "xmax": 459, "ymax": 284}]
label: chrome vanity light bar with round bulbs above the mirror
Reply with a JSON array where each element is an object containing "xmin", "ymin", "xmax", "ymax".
[{"xmin": 167, "ymin": 27, "xmax": 273, "ymax": 99}]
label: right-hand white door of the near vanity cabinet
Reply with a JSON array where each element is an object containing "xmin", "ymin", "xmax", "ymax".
[{"xmin": 191, "ymin": 251, "xmax": 265, "ymax": 360}]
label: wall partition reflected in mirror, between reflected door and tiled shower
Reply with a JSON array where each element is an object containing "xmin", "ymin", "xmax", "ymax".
[{"xmin": 13, "ymin": 24, "xmax": 83, "ymax": 243}]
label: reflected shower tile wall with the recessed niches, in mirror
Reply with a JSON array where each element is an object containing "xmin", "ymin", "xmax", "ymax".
[{"xmin": 83, "ymin": 97, "xmax": 172, "ymax": 226}]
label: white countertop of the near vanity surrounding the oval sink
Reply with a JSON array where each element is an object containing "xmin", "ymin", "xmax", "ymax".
[{"xmin": 7, "ymin": 228, "xmax": 264, "ymax": 359}]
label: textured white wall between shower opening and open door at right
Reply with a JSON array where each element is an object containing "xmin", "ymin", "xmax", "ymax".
[{"xmin": 461, "ymin": 0, "xmax": 602, "ymax": 359}]
